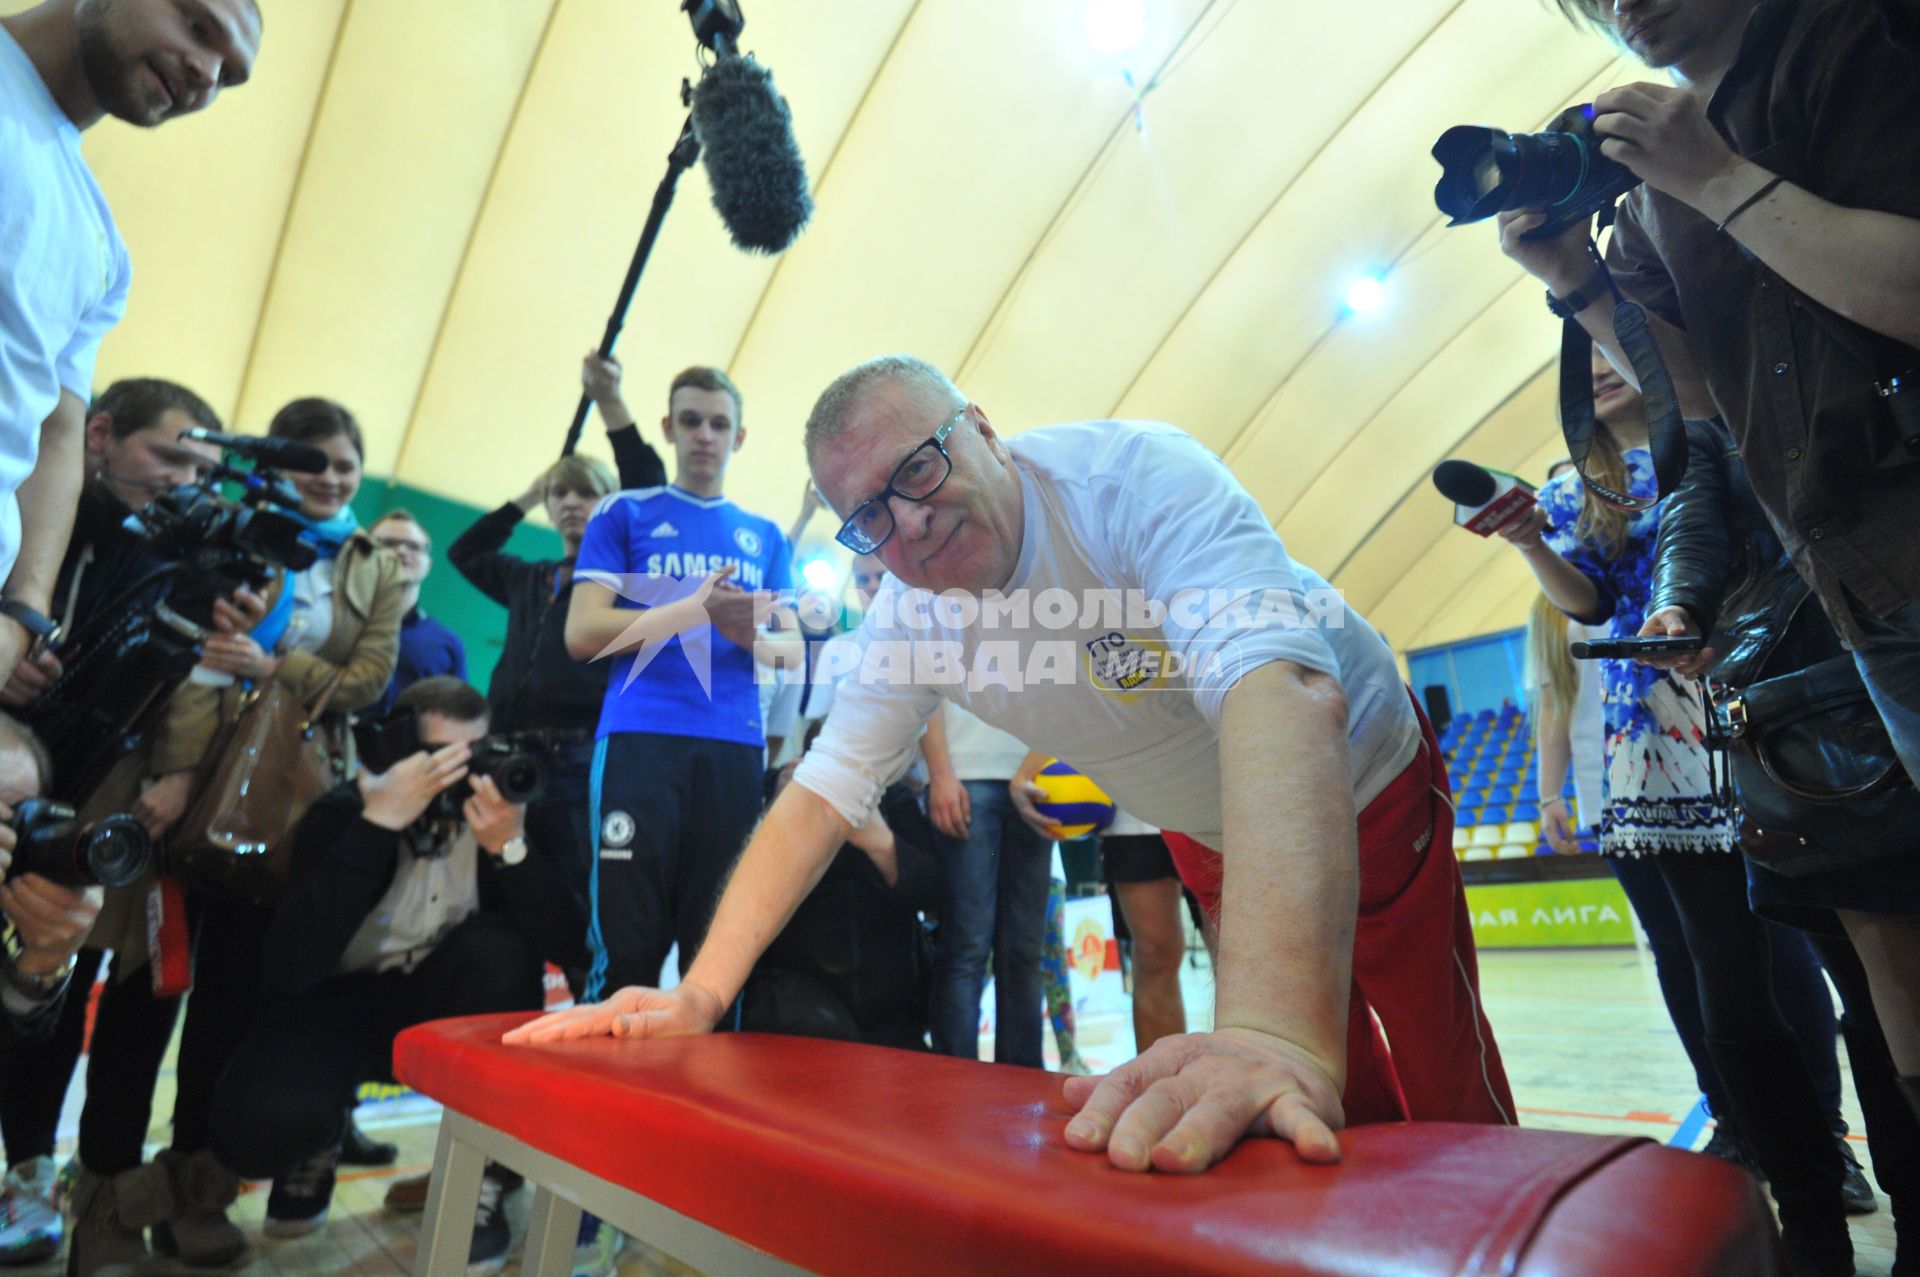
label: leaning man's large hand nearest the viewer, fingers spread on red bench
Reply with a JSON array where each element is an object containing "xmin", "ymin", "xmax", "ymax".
[{"xmin": 1066, "ymin": 1027, "xmax": 1346, "ymax": 1173}]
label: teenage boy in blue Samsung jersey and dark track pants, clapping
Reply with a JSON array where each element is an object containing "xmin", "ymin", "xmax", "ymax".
[{"xmin": 566, "ymin": 367, "xmax": 793, "ymax": 1002}]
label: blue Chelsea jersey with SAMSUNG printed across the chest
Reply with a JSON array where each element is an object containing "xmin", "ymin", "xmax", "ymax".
[{"xmin": 574, "ymin": 486, "xmax": 793, "ymax": 747}]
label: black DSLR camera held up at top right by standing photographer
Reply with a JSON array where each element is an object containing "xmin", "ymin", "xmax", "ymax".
[{"xmin": 1432, "ymin": 104, "xmax": 1640, "ymax": 240}]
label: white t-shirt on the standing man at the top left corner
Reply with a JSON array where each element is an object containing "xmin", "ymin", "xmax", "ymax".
[{"xmin": 0, "ymin": 29, "xmax": 132, "ymax": 582}]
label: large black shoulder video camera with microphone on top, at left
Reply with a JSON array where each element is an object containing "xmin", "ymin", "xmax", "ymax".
[{"xmin": 23, "ymin": 436, "xmax": 315, "ymax": 801}]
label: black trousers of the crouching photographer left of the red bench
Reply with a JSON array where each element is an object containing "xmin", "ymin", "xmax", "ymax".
[{"xmin": 211, "ymin": 914, "xmax": 545, "ymax": 1179}]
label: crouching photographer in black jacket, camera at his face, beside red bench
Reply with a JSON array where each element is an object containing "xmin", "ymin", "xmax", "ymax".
[{"xmin": 213, "ymin": 678, "xmax": 586, "ymax": 1262}]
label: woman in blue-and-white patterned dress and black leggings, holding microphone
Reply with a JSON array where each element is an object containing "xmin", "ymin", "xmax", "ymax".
[{"xmin": 1500, "ymin": 351, "xmax": 1853, "ymax": 1273}]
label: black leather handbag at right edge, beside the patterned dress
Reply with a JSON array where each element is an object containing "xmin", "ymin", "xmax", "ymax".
[{"xmin": 1707, "ymin": 655, "xmax": 1920, "ymax": 878}]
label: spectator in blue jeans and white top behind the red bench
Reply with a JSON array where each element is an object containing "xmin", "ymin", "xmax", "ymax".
[{"xmin": 922, "ymin": 705, "xmax": 1052, "ymax": 1068}]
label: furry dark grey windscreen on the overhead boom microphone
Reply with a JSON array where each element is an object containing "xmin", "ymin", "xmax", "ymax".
[{"xmin": 693, "ymin": 56, "xmax": 814, "ymax": 253}]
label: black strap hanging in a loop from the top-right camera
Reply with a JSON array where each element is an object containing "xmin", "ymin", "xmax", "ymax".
[{"xmin": 1561, "ymin": 234, "xmax": 1688, "ymax": 511}]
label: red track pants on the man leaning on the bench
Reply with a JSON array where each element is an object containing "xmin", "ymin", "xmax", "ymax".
[{"xmin": 1165, "ymin": 705, "xmax": 1513, "ymax": 1125}]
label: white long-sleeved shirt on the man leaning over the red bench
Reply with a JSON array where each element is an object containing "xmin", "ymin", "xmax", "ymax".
[{"xmin": 795, "ymin": 421, "xmax": 1419, "ymax": 849}]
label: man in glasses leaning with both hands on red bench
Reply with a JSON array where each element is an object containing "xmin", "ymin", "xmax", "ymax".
[{"xmin": 507, "ymin": 355, "xmax": 1513, "ymax": 1171}]
